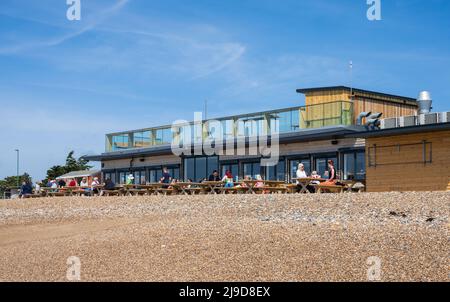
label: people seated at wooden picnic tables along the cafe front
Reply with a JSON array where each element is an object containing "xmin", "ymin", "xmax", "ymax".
[{"xmin": 21, "ymin": 160, "xmax": 337, "ymax": 197}]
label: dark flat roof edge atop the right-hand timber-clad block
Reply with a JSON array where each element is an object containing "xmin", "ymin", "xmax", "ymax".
[{"xmin": 346, "ymin": 122, "xmax": 450, "ymax": 138}]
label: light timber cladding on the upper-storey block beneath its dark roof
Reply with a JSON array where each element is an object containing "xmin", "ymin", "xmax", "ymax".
[{"xmin": 305, "ymin": 88, "xmax": 418, "ymax": 123}]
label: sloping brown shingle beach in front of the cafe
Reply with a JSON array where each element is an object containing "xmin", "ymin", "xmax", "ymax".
[{"xmin": 0, "ymin": 192, "xmax": 450, "ymax": 281}]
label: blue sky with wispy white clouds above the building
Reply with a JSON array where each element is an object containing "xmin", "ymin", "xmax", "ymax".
[{"xmin": 0, "ymin": 0, "xmax": 450, "ymax": 179}]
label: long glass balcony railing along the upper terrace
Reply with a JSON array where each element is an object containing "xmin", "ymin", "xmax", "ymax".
[{"xmin": 106, "ymin": 101, "xmax": 354, "ymax": 152}]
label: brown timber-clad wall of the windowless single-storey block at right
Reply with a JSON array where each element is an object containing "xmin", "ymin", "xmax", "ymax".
[{"xmin": 366, "ymin": 130, "xmax": 450, "ymax": 192}]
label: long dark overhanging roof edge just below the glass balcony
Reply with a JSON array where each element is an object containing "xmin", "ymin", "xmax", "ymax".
[{"xmin": 82, "ymin": 126, "xmax": 366, "ymax": 161}]
